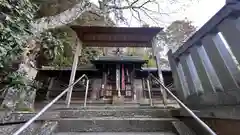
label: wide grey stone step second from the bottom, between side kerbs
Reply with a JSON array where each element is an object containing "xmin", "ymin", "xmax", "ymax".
[{"xmin": 57, "ymin": 117, "xmax": 177, "ymax": 132}]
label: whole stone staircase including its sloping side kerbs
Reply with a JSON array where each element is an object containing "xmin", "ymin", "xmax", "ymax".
[{"xmin": 0, "ymin": 106, "xmax": 195, "ymax": 135}]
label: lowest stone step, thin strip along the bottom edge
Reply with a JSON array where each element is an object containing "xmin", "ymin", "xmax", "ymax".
[{"xmin": 54, "ymin": 132, "xmax": 176, "ymax": 135}]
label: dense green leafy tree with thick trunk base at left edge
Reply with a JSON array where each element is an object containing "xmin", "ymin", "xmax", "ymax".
[{"xmin": 0, "ymin": 0, "xmax": 40, "ymax": 109}]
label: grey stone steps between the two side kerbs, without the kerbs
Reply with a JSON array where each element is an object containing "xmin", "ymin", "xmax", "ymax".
[{"xmin": 56, "ymin": 108, "xmax": 176, "ymax": 133}]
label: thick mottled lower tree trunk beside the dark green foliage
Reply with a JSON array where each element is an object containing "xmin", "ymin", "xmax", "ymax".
[{"xmin": 2, "ymin": 40, "xmax": 37, "ymax": 111}]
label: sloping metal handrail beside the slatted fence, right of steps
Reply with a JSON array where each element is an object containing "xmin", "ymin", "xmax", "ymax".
[{"xmin": 150, "ymin": 74, "xmax": 217, "ymax": 135}]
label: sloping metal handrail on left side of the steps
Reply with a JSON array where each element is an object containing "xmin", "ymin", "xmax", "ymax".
[{"xmin": 13, "ymin": 74, "xmax": 89, "ymax": 135}]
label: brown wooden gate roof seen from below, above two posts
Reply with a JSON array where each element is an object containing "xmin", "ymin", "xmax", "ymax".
[{"xmin": 71, "ymin": 25, "xmax": 162, "ymax": 47}]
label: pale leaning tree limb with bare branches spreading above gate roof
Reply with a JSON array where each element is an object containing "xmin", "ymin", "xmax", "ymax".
[{"xmin": 32, "ymin": 0, "xmax": 197, "ymax": 33}]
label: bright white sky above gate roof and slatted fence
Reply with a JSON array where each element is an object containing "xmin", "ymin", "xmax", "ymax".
[{"xmin": 90, "ymin": 0, "xmax": 225, "ymax": 27}]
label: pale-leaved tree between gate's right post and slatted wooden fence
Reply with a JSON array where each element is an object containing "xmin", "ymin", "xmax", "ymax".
[{"xmin": 150, "ymin": 20, "xmax": 196, "ymax": 69}]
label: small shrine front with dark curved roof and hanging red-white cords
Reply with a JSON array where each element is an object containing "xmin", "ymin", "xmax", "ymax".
[{"xmin": 92, "ymin": 56, "xmax": 147, "ymax": 100}]
